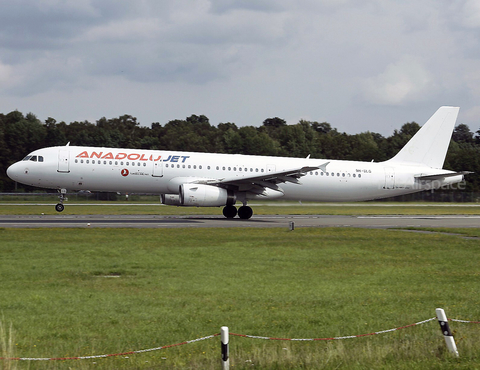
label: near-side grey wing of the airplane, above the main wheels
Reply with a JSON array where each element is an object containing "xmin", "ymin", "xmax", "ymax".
[{"xmin": 202, "ymin": 162, "xmax": 330, "ymax": 194}]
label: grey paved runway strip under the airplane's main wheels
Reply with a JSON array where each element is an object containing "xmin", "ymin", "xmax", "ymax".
[{"xmin": 0, "ymin": 215, "xmax": 480, "ymax": 228}]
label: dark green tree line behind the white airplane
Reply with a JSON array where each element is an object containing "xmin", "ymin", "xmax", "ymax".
[{"xmin": 0, "ymin": 111, "xmax": 480, "ymax": 192}]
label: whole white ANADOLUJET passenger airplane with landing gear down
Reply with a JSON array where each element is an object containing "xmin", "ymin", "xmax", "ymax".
[{"xmin": 7, "ymin": 107, "xmax": 471, "ymax": 219}]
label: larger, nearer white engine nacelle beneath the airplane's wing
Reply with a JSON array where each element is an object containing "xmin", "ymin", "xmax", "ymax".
[{"xmin": 179, "ymin": 184, "xmax": 236, "ymax": 207}]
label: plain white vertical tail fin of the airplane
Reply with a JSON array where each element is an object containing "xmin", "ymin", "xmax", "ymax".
[{"xmin": 387, "ymin": 107, "xmax": 460, "ymax": 168}]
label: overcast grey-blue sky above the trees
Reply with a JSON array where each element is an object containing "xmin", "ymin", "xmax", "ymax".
[{"xmin": 0, "ymin": 0, "xmax": 480, "ymax": 136}]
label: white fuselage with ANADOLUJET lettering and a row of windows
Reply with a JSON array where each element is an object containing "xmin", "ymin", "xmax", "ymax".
[{"xmin": 3, "ymin": 146, "xmax": 463, "ymax": 201}]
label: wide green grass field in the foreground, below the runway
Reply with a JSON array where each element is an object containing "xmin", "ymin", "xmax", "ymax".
[{"xmin": 0, "ymin": 228, "xmax": 480, "ymax": 369}]
